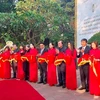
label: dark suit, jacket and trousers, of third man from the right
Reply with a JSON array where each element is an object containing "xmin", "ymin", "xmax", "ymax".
[{"xmin": 39, "ymin": 48, "xmax": 48, "ymax": 82}]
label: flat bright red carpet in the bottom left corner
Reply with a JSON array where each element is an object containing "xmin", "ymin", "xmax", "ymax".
[{"xmin": 0, "ymin": 80, "xmax": 45, "ymax": 100}]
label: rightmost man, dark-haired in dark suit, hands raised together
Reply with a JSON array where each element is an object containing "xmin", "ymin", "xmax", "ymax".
[{"xmin": 77, "ymin": 39, "xmax": 90, "ymax": 92}]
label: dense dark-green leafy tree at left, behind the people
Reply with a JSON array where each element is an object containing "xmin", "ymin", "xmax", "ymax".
[{"xmin": 0, "ymin": 12, "xmax": 46, "ymax": 44}]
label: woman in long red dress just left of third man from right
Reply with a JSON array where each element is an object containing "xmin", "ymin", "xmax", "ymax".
[{"xmin": 29, "ymin": 44, "xmax": 38, "ymax": 82}]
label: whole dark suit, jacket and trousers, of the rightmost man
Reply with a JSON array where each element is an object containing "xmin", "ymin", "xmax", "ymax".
[{"xmin": 77, "ymin": 46, "xmax": 90, "ymax": 89}]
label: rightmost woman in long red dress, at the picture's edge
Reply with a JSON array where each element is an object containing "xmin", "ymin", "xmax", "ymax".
[{"xmin": 90, "ymin": 41, "xmax": 100, "ymax": 98}]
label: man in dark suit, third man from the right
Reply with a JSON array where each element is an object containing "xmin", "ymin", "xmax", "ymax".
[{"xmin": 38, "ymin": 43, "xmax": 48, "ymax": 84}]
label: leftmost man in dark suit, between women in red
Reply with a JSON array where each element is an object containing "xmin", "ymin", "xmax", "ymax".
[{"xmin": 11, "ymin": 44, "xmax": 19, "ymax": 78}]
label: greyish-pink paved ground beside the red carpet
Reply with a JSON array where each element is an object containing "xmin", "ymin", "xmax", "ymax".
[{"xmin": 30, "ymin": 71, "xmax": 100, "ymax": 100}]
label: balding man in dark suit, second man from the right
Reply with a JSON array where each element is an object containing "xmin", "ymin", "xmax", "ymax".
[{"xmin": 57, "ymin": 41, "xmax": 66, "ymax": 88}]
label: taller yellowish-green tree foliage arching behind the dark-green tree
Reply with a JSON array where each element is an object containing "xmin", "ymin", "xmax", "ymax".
[{"xmin": 16, "ymin": 0, "xmax": 73, "ymax": 42}]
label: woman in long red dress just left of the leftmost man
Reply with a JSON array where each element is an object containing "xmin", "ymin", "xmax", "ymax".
[{"xmin": 2, "ymin": 46, "xmax": 11, "ymax": 79}]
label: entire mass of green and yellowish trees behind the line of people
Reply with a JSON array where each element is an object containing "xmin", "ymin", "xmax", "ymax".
[{"xmin": 0, "ymin": 0, "xmax": 74, "ymax": 44}]
